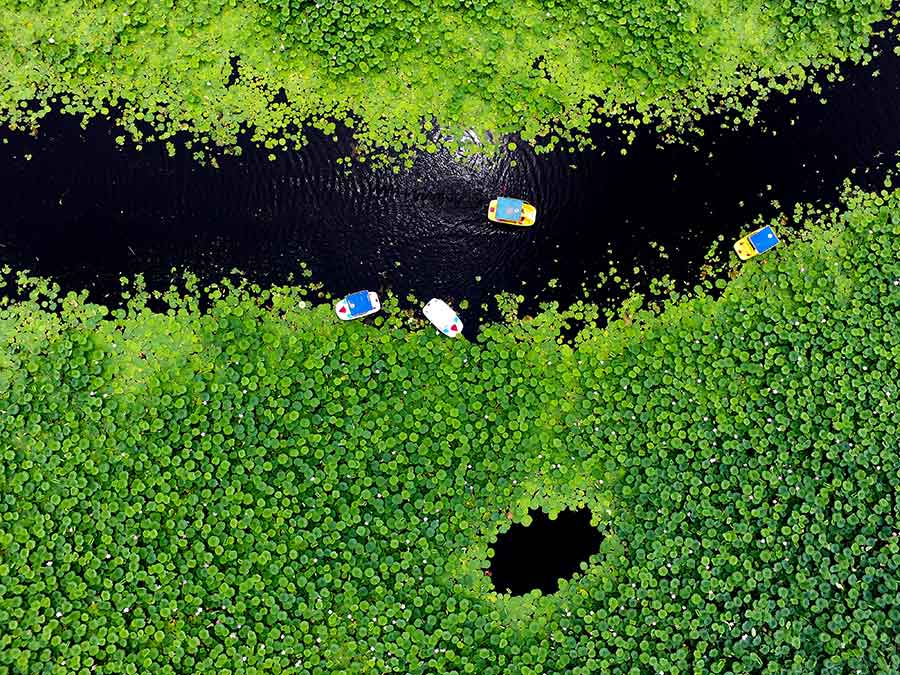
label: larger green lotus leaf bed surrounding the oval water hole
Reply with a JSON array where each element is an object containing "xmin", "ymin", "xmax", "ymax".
[{"xmin": 0, "ymin": 184, "xmax": 900, "ymax": 675}]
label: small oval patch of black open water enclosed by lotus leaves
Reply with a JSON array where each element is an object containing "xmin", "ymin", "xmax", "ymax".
[{"xmin": 489, "ymin": 509, "xmax": 603, "ymax": 595}]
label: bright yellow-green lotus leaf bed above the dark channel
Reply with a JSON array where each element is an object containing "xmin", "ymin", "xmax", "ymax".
[{"xmin": 0, "ymin": 0, "xmax": 894, "ymax": 161}]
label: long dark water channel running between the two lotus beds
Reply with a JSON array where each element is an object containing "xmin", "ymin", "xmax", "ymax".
[{"xmin": 0, "ymin": 30, "xmax": 900, "ymax": 332}]
